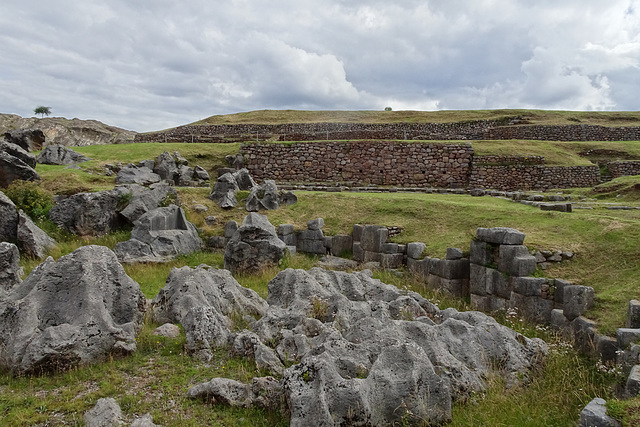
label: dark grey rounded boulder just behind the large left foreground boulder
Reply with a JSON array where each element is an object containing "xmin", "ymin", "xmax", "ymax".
[{"xmin": 49, "ymin": 187, "xmax": 131, "ymax": 236}]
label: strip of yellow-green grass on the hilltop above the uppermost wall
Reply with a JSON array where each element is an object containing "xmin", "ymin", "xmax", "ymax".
[{"xmin": 191, "ymin": 110, "xmax": 640, "ymax": 126}]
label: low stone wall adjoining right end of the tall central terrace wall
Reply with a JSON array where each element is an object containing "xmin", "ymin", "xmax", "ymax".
[{"xmin": 468, "ymin": 162, "xmax": 600, "ymax": 191}]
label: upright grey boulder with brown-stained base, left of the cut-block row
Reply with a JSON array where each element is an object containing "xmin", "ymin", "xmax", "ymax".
[{"xmin": 224, "ymin": 212, "xmax": 286, "ymax": 273}]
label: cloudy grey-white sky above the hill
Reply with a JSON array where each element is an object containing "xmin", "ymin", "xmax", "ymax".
[{"xmin": 0, "ymin": 0, "xmax": 640, "ymax": 132}]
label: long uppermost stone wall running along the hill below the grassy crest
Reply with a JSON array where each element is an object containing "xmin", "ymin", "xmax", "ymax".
[{"xmin": 135, "ymin": 121, "xmax": 640, "ymax": 143}]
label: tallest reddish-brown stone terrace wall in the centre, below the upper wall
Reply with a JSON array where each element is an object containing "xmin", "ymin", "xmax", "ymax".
[{"xmin": 241, "ymin": 141, "xmax": 473, "ymax": 188}]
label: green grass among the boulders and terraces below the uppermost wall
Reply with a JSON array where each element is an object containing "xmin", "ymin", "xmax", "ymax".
[{"xmin": 0, "ymin": 139, "xmax": 640, "ymax": 426}]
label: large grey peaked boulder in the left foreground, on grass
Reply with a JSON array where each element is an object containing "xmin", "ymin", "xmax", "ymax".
[{"xmin": 0, "ymin": 245, "xmax": 146, "ymax": 374}]
